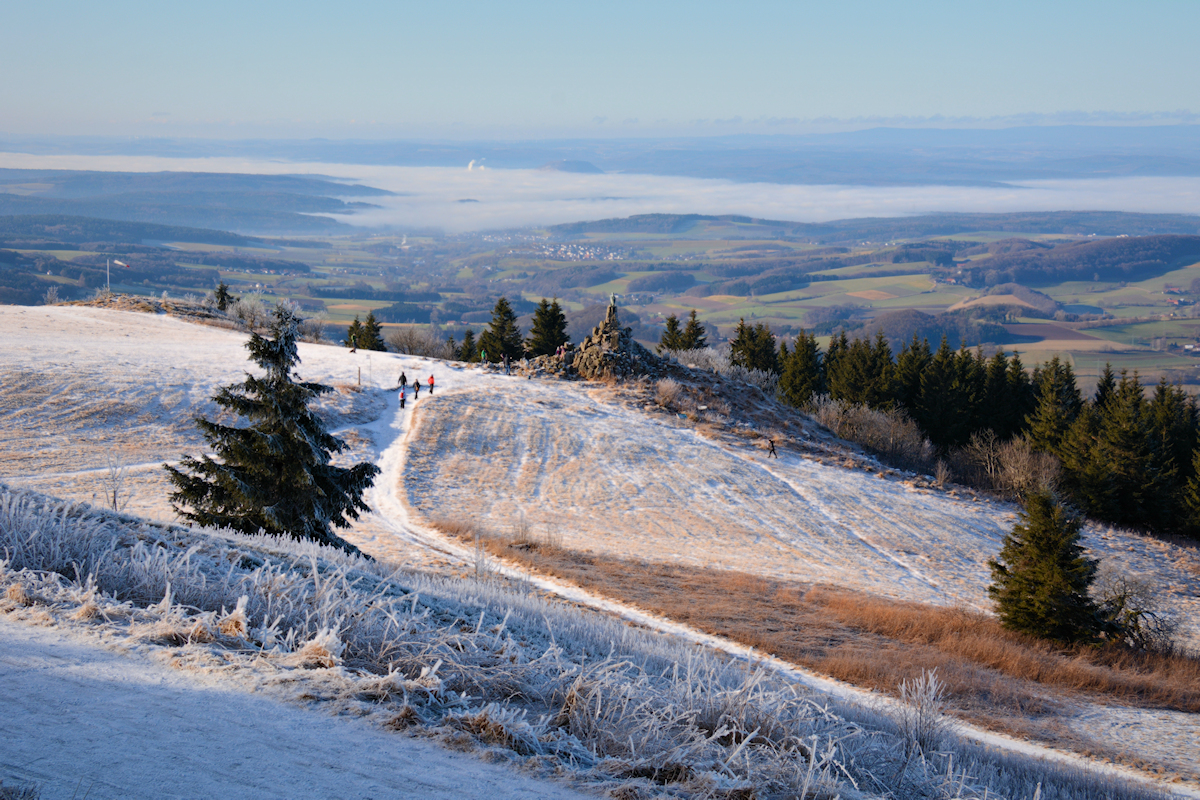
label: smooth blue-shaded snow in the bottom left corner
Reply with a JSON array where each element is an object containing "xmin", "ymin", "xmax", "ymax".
[{"xmin": 0, "ymin": 618, "xmax": 587, "ymax": 800}]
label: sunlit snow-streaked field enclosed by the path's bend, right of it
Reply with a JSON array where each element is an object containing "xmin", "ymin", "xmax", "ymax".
[{"xmin": 403, "ymin": 377, "xmax": 1200, "ymax": 644}]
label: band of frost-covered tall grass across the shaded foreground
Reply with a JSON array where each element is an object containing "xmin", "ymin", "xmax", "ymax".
[{"xmin": 0, "ymin": 487, "xmax": 1162, "ymax": 800}]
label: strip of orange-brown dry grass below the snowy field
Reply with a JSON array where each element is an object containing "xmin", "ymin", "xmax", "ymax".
[{"xmin": 436, "ymin": 522, "xmax": 1200, "ymax": 734}]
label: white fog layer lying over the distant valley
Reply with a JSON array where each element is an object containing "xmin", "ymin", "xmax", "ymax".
[{"xmin": 0, "ymin": 154, "xmax": 1200, "ymax": 231}]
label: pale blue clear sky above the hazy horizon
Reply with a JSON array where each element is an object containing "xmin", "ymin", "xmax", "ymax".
[{"xmin": 0, "ymin": 0, "xmax": 1200, "ymax": 138}]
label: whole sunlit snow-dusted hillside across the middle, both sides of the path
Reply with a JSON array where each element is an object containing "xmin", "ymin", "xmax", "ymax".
[{"xmin": 7, "ymin": 306, "xmax": 1200, "ymax": 796}]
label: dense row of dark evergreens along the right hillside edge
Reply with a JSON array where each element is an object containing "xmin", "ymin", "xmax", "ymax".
[{"xmin": 731, "ymin": 321, "xmax": 1200, "ymax": 536}]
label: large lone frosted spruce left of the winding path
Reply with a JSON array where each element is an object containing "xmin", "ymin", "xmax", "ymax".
[{"xmin": 163, "ymin": 306, "xmax": 379, "ymax": 552}]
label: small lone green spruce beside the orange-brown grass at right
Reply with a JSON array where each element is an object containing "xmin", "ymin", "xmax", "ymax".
[{"xmin": 988, "ymin": 492, "xmax": 1098, "ymax": 643}]
